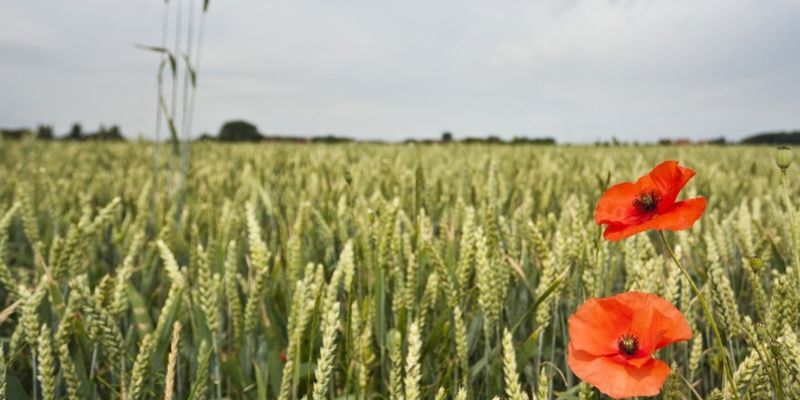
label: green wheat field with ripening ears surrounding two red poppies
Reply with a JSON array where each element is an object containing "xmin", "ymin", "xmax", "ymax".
[{"xmin": 0, "ymin": 141, "xmax": 800, "ymax": 400}]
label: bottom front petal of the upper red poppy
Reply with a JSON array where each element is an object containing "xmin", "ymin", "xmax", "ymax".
[{"xmin": 603, "ymin": 197, "xmax": 706, "ymax": 241}]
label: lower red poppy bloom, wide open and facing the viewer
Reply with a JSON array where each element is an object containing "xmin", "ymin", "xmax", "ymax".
[{"xmin": 567, "ymin": 292, "xmax": 692, "ymax": 399}]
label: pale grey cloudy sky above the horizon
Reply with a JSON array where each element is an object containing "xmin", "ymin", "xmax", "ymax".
[{"xmin": 0, "ymin": 0, "xmax": 800, "ymax": 142}]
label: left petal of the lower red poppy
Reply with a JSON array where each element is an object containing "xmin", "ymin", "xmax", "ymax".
[{"xmin": 568, "ymin": 297, "xmax": 633, "ymax": 356}]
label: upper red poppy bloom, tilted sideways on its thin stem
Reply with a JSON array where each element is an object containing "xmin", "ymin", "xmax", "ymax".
[{"xmin": 594, "ymin": 161, "xmax": 706, "ymax": 241}]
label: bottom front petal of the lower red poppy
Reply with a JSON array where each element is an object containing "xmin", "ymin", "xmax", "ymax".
[{"xmin": 567, "ymin": 343, "xmax": 669, "ymax": 399}]
